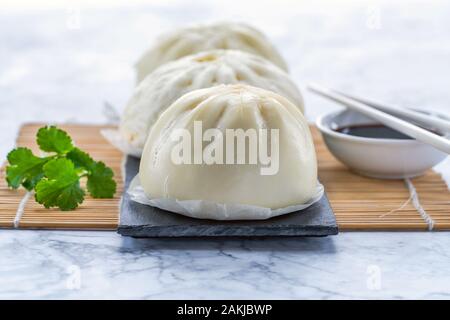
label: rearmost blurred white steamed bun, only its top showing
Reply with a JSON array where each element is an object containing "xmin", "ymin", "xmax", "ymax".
[{"xmin": 136, "ymin": 22, "xmax": 287, "ymax": 83}]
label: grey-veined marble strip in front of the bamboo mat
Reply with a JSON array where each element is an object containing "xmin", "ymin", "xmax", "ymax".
[{"xmin": 0, "ymin": 230, "xmax": 450, "ymax": 299}]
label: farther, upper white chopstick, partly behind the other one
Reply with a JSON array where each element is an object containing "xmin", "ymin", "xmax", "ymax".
[{"xmin": 331, "ymin": 89, "xmax": 450, "ymax": 134}]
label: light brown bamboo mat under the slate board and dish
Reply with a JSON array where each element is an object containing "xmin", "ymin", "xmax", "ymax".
[{"xmin": 0, "ymin": 124, "xmax": 450, "ymax": 231}]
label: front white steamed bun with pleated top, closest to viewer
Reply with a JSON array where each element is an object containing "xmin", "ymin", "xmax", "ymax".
[{"xmin": 139, "ymin": 85, "xmax": 317, "ymax": 209}]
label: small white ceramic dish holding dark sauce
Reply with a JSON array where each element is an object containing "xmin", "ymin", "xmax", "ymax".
[{"xmin": 316, "ymin": 110, "xmax": 448, "ymax": 179}]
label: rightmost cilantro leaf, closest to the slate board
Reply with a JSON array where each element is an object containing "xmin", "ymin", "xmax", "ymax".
[{"xmin": 87, "ymin": 161, "xmax": 116, "ymax": 198}]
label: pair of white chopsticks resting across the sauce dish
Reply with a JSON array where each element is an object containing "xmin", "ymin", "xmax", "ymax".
[{"xmin": 308, "ymin": 84, "xmax": 450, "ymax": 154}]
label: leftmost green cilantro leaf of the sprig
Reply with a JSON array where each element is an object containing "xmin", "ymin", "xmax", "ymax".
[{"xmin": 6, "ymin": 148, "xmax": 48, "ymax": 190}]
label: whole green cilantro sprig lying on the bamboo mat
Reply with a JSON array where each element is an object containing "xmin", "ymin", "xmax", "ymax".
[{"xmin": 6, "ymin": 126, "xmax": 116, "ymax": 210}]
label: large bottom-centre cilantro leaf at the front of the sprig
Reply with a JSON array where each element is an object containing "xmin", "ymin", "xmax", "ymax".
[{"xmin": 35, "ymin": 158, "xmax": 85, "ymax": 210}]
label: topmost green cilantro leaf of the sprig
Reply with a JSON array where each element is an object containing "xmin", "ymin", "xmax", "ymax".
[{"xmin": 37, "ymin": 126, "xmax": 74, "ymax": 154}]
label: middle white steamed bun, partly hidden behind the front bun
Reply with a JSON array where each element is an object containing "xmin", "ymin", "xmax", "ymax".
[{"xmin": 120, "ymin": 50, "xmax": 303, "ymax": 154}]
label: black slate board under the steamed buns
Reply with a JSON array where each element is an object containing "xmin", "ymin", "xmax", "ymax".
[{"xmin": 118, "ymin": 157, "xmax": 338, "ymax": 238}]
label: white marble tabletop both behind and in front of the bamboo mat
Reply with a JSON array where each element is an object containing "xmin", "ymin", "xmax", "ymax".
[{"xmin": 0, "ymin": 0, "xmax": 450, "ymax": 299}]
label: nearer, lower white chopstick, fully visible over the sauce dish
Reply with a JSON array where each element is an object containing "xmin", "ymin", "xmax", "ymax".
[{"xmin": 308, "ymin": 84, "xmax": 450, "ymax": 154}]
